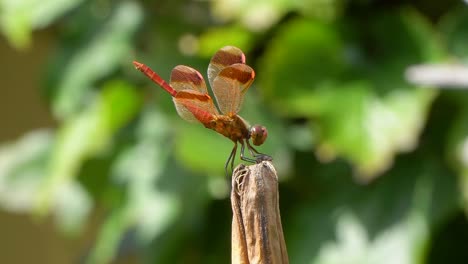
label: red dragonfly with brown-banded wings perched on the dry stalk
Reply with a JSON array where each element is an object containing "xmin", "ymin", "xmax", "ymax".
[{"xmin": 133, "ymin": 46, "xmax": 272, "ymax": 174}]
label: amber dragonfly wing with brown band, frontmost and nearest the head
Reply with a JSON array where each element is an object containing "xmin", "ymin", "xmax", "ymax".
[{"xmin": 211, "ymin": 63, "xmax": 255, "ymax": 115}]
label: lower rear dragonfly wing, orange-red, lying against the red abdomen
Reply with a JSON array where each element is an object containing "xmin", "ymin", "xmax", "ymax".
[{"xmin": 173, "ymin": 90, "xmax": 218, "ymax": 124}]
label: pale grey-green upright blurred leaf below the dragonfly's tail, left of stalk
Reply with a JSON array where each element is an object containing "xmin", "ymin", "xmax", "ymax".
[{"xmin": 113, "ymin": 107, "xmax": 177, "ymax": 241}]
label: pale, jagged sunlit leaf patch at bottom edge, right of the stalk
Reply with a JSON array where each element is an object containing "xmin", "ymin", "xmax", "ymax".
[{"xmin": 313, "ymin": 212, "xmax": 428, "ymax": 264}]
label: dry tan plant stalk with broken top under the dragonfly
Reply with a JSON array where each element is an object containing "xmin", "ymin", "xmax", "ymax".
[{"xmin": 231, "ymin": 161, "xmax": 289, "ymax": 264}]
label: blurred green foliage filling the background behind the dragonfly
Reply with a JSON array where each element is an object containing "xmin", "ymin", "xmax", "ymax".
[{"xmin": 0, "ymin": 0, "xmax": 468, "ymax": 263}]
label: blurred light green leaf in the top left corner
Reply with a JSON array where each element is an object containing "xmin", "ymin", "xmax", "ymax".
[{"xmin": 0, "ymin": 0, "xmax": 83, "ymax": 49}]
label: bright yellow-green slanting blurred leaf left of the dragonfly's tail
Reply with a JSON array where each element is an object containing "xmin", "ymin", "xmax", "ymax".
[{"xmin": 36, "ymin": 81, "xmax": 141, "ymax": 217}]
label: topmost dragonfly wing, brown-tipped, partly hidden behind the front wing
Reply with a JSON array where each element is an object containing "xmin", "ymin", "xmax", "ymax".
[{"xmin": 208, "ymin": 46, "xmax": 245, "ymax": 87}]
